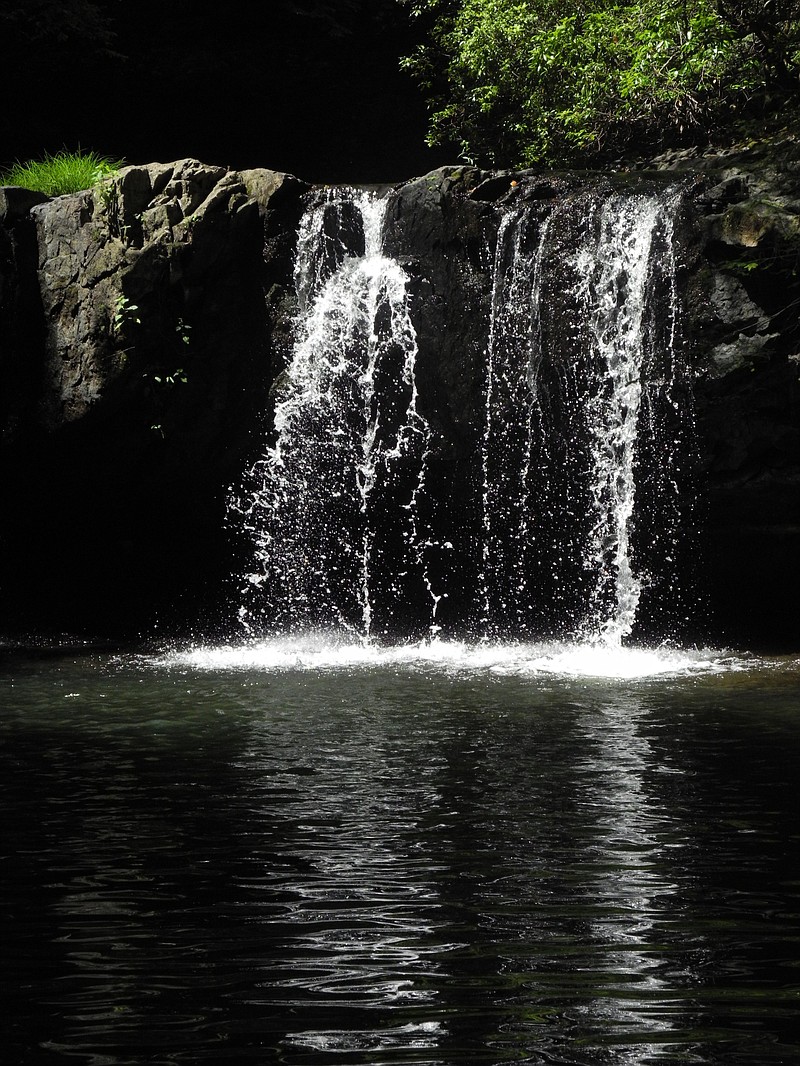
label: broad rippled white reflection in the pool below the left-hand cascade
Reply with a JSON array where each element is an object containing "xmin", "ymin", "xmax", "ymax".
[{"xmin": 234, "ymin": 707, "xmax": 454, "ymax": 1052}]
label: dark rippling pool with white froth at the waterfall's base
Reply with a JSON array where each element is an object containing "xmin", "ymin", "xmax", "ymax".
[{"xmin": 0, "ymin": 635, "xmax": 800, "ymax": 1066}]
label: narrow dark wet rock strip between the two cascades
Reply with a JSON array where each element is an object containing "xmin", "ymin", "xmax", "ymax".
[{"xmin": 385, "ymin": 167, "xmax": 497, "ymax": 629}]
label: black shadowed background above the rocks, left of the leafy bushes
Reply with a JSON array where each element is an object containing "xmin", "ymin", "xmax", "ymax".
[{"xmin": 0, "ymin": 0, "xmax": 458, "ymax": 182}]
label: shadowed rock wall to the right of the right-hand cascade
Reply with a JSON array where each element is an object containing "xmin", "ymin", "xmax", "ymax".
[{"xmin": 654, "ymin": 134, "xmax": 800, "ymax": 648}]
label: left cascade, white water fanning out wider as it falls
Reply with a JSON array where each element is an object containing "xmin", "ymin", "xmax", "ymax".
[{"xmin": 231, "ymin": 189, "xmax": 428, "ymax": 637}]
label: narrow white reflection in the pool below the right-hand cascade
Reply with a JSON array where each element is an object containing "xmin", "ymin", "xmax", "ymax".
[{"xmin": 576, "ymin": 696, "xmax": 690, "ymax": 1064}]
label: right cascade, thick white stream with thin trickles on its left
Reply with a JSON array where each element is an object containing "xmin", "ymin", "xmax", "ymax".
[{"xmin": 482, "ymin": 190, "xmax": 681, "ymax": 645}]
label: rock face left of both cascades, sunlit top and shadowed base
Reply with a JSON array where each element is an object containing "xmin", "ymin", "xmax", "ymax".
[{"xmin": 0, "ymin": 160, "xmax": 305, "ymax": 631}]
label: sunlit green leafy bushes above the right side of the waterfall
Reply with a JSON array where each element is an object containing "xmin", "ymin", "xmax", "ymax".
[{"xmin": 400, "ymin": 0, "xmax": 800, "ymax": 165}]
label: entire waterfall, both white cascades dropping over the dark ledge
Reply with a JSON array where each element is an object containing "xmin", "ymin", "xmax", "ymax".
[{"xmin": 229, "ymin": 181, "xmax": 690, "ymax": 646}]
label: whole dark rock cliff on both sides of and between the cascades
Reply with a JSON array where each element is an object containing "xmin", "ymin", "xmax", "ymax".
[{"xmin": 0, "ymin": 150, "xmax": 800, "ymax": 645}]
